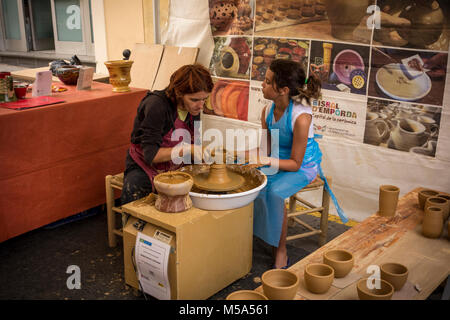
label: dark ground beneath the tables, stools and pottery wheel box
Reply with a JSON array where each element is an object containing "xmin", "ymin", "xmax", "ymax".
[{"xmin": 0, "ymin": 207, "xmax": 349, "ymax": 300}]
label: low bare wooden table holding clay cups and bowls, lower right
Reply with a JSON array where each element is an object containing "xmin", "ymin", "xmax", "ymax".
[{"xmin": 257, "ymin": 188, "xmax": 450, "ymax": 300}]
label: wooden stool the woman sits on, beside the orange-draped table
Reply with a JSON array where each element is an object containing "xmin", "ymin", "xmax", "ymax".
[{"xmin": 105, "ymin": 172, "xmax": 123, "ymax": 247}]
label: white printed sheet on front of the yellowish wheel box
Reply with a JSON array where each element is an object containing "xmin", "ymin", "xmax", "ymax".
[{"xmin": 135, "ymin": 232, "xmax": 170, "ymax": 300}]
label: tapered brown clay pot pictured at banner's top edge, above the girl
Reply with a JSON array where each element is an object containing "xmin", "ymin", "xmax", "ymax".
[{"xmin": 325, "ymin": 0, "xmax": 371, "ymax": 40}]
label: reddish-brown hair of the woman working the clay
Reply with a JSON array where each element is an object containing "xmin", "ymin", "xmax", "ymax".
[{"xmin": 165, "ymin": 63, "xmax": 214, "ymax": 103}]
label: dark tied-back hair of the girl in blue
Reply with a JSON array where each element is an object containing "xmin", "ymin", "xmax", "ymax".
[{"xmin": 269, "ymin": 59, "xmax": 322, "ymax": 104}]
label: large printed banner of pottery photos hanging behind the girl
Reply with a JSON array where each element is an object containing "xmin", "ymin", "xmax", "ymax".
[{"xmin": 204, "ymin": 0, "xmax": 450, "ymax": 157}]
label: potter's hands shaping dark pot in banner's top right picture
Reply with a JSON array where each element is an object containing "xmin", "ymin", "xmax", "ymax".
[{"xmin": 374, "ymin": 12, "xmax": 411, "ymax": 46}]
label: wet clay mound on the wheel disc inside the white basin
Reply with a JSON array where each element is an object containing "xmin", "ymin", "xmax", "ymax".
[{"xmin": 194, "ymin": 164, "xmax": 245, "ymax": 192}]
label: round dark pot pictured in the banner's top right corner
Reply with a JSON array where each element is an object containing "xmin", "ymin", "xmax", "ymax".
[{"xmin": 397, "ymin": 1, "xmax": 445, "ymax": 47}]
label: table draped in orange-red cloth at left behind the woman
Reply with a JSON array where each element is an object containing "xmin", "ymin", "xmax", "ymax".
[{"xmin": 0, "ymin": 82, "xmax": 147, "ymax": 242}]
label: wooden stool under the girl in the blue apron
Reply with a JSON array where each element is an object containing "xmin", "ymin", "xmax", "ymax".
[{"xmin": 286, "ymin": 176, "xmax": 331, "ymax": 246}]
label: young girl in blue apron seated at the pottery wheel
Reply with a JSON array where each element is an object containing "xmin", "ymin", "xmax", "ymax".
[{"xmin": 254, "ymin": 59, "xmax": 347, "ymax": 268}]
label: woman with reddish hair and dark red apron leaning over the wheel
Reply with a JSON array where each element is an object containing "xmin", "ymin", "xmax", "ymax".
[{"xmin": 121, "ymin": 64, "xmax": 213, "ymax": 211}]
